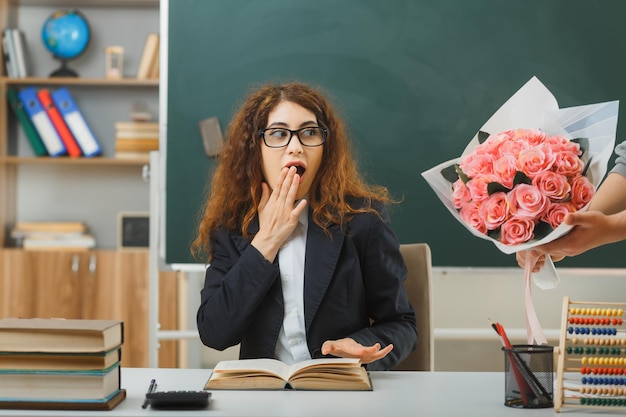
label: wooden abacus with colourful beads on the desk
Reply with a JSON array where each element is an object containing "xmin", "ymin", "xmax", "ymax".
[{"xmin": 554, "ymin": 297, "xmax": 626, "ymax": 413}]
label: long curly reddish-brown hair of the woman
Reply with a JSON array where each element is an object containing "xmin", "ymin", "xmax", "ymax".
[{"xmin": 191, "ymin": 82, "xmax": 391, "ymax": 262}]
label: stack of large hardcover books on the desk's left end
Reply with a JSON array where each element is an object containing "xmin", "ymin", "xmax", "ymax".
[{"xmin": 0, "ymin": 318, "xmax": 126, "ymax": 410}]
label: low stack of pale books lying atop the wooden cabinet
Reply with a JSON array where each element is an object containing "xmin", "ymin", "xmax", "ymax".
[{"xmin": 11, "ymin": 222, "xmax": 96, "ymax": 251}]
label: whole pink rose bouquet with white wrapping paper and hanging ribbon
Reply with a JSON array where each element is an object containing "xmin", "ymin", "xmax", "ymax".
[{"xmin": 422, "ymin": 77, "xmax": 619, "ymax": 344}]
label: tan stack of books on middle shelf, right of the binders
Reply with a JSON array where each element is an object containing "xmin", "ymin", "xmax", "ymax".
[{"xmin": 115, "ymin": 122, "xmax": 159, "ymax": 160}]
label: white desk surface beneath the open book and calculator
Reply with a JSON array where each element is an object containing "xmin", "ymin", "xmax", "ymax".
[{"xmin": 0, "ymin": 368, "xmax": 613, "ymax": 417}]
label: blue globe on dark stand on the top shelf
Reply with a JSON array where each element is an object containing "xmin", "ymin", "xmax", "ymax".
[{"xmin": 41, "ymin": 10, "xmax": 91, "ymax": 77}]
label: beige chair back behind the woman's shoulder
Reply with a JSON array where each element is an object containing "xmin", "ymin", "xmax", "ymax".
[{"xmin": 394, "ymin": 243, "xmax": 435, "ymax": 371}]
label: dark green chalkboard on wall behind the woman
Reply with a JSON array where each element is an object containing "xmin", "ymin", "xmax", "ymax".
[{"xmin": 165, "ymin": 0, "xmax": 626, "ymax": 267}]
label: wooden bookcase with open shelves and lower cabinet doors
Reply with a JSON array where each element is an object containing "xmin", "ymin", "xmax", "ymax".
[{"xmin": 0, "ymin": 0, "xmax": 178, "ymax": 366}]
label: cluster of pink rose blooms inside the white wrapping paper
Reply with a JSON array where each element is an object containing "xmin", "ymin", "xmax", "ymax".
[{"xmin": 442, "ymin": 129, "xmax": 594, "ymax": 245}]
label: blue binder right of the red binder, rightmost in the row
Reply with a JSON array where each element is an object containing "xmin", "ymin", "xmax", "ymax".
[{"xmin": 51, "ymin": 87, "xmax": 102, "ymax": 157}]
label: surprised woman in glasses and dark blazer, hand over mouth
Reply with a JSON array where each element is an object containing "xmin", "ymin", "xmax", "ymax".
[{"xmin": 192, "ymin": 83, "xmax": 417, "ymax": 370}]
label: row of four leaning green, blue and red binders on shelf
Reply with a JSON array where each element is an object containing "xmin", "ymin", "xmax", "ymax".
[{"xmin": 6, "ymin": 87, "xmax": 102, "ymax": 158}]
